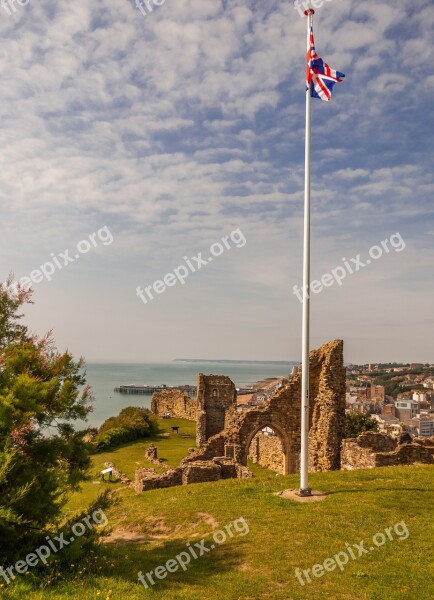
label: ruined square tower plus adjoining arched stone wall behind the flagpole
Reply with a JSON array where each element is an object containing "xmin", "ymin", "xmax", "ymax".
[{"xmin": 184, "ymin": 340, "xmax": 345, "ymax": 474}]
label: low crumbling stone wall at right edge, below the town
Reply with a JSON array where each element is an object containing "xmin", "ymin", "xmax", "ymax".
[{"xmin": 341, "ymin": 432, "xmax": 434, "ymax": 471}]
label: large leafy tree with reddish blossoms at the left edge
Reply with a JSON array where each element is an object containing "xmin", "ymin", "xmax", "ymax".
[{"xmin": 0, "ymin": 277, "xmax": 93, "ymax": 564}]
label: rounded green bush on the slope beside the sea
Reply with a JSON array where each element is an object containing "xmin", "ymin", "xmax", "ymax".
[{"xmin": 95, "ymin": 406, "xmax": 158, "ymax": 451}]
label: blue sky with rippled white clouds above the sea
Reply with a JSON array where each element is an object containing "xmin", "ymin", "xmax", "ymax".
[{"xmin": 0, "ymin": 0, "xmax": 434, "ymax": 363}]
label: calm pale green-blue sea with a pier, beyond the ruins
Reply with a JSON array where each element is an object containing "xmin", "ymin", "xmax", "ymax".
[{"xmin": 75, "ymin": 361, "xmax": 299, "ymax": 429}]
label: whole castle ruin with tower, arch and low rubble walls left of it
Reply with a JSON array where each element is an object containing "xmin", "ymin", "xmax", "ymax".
[{"xmin": 132, "ymin": 340, "xmax": 345, "ymax": 492}]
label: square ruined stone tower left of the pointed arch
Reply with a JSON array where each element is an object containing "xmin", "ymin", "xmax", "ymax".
[{"xmin": 196, "ymin": 373, "xmax": 237, "ymax": 446}]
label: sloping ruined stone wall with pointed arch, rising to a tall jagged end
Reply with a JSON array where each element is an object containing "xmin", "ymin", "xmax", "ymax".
[{"xmin": 222, "ymin": 340, "xmax": 345, "ymax": 474}]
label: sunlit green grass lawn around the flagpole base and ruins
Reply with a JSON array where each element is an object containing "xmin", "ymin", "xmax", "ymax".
[{"xmin": 3, "ymin": 422, "xmax": 434, "ymax": 600}]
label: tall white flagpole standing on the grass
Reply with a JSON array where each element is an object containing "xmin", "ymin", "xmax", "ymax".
[{"xmin": 299, "ymin": 9, "xmax": 315, "ymax": 496}]
